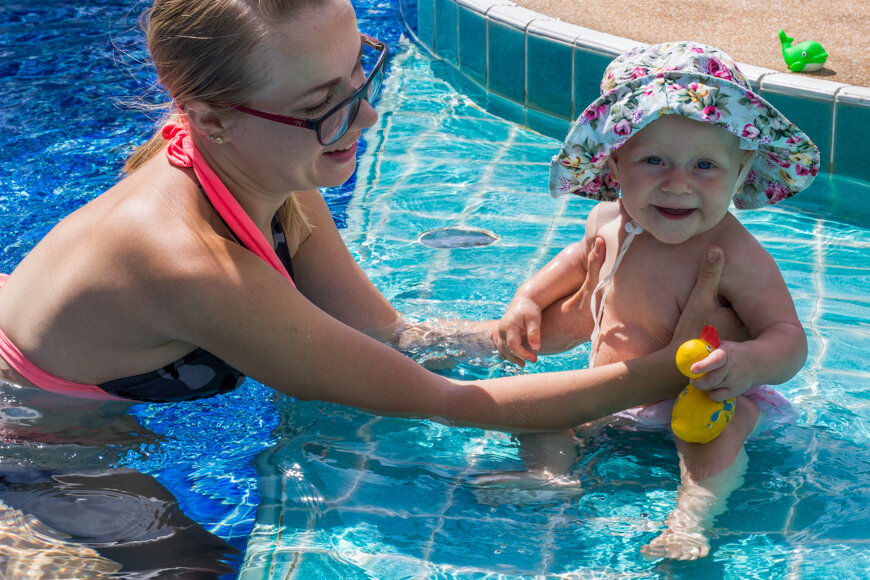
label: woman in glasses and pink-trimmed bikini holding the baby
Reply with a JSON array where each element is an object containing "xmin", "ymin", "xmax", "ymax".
[{"xmin": 0, "ymin": 0, "xmax": 740, "ymax": 431}]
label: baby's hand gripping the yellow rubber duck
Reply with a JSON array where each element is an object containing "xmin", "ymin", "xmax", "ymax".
[{"xmin": 692, "ymin": 341, "xmax": 758, "ymax": 401}]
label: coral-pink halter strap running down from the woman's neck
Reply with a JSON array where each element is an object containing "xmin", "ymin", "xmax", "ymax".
[{"xmin": 163, "ymin": 121, "xmax": 296, "ymax": 286}]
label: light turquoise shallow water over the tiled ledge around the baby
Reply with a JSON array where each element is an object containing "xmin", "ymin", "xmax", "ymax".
[{"xmin": 242, "ymin": 39, "xmax": 870, "ymax": 579}]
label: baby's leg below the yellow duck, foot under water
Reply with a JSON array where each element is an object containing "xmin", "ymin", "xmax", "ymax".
[{"xmin": 641, "ymin": 396, "xmax": 759, "ymax": 560}]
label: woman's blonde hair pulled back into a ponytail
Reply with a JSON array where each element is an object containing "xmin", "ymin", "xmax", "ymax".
[{"xmin": 124, "ymin": 0, "xmax": 324, "ymax": 234}]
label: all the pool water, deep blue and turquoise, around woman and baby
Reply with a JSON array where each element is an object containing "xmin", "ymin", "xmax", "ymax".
[{"xmin": 0, "ymin": 0, "xmax": 870, "ymax": 579}]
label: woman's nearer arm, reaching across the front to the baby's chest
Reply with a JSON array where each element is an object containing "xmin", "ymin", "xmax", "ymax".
[{"xmin": 166, "ymin": 224, "xmax": 721, "ymax": 430}]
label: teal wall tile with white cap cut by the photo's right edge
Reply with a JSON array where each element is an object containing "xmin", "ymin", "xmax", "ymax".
[{"xmin": 833, "ymin": 87, "xmax": 870, "ymax": 181}]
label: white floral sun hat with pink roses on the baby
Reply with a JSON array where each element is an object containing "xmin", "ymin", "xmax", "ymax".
[{"xmin": 550, "ymin": 42, "xmax": 819, "ymax": 209}]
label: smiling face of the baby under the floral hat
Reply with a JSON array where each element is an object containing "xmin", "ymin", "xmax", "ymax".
[{"xmin": 610, "ymin": 115, "xmax": 749, "ymax": 244}]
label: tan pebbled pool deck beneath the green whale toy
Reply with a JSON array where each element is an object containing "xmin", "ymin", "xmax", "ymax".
[{"xmin": 514, "ymin": 0, "xmax": 870, "ymax": 87}]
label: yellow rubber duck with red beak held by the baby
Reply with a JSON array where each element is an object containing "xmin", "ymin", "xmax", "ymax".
[{"xmin": 671, "ymin": 326, "xmax": 735, "ymax": 443}]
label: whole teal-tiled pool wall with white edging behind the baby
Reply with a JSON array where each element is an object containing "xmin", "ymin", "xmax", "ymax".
[{"xmin": 401, "ymin": 0, "xmax": 870, "ymax": 180}]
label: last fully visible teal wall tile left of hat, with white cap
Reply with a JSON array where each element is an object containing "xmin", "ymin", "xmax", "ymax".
[{"xmin": 526, "ymin": 20, "xmax": 580, "ymax": 119}]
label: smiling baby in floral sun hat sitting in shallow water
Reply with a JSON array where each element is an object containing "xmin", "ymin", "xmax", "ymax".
[{"xmin": 499, "ymin": 42, "xmax": 819, "ymax": 559}]
